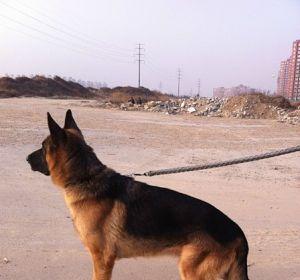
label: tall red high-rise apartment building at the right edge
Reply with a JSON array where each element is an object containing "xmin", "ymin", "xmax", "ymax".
[{"xmin": 277, "ymin": 40, "xmax": 300, "ymax": 100}]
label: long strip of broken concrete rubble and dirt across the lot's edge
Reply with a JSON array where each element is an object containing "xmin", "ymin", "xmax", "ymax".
[{"xmin": 92, "ymin": 94, "xmax": 300, "ymax": 124}]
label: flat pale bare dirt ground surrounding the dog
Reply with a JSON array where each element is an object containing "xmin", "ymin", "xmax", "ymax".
[{"xmin": 0, "ymin": 98, "xmax": 300, "ymax": 280}]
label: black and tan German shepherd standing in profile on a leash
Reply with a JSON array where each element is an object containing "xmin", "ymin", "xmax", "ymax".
[{"xmin": 27, "ymin": 110, "xmax": 248, "ymax": 280}]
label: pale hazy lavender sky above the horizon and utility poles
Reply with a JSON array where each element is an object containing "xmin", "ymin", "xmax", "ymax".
[{"xmin": 0, "ymin": 0, "xmax": 300, "ymax": 96}]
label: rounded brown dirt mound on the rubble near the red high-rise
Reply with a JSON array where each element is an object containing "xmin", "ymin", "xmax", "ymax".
[{"xmin": 222, "ymin": 93, "xmax": 293, "ymax": 119}]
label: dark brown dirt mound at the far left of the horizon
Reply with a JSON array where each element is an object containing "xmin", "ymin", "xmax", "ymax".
[{"xmin": 0, "ymin": 76, "xmax": 94, "ymax": 98}]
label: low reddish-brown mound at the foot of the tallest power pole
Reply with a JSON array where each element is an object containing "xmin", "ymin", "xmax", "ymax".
[{"xmin": 98, "ymin": 86, "xmax": 170, "ymax": 104}]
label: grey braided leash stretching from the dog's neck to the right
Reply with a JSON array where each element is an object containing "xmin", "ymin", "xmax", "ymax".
[{"xmin": 129, "ymin": 145, "xmax": 300, "ymax": 177}]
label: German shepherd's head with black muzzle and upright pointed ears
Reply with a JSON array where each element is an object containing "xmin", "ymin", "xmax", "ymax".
[{"xmin": 26, "ymin": 110, "xmax": 89, "ymax": 185}]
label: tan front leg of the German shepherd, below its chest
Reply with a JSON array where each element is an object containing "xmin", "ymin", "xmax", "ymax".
[{"xmin": 92, "ymin": 253, "xmax": 115, "ymax": 280}]
